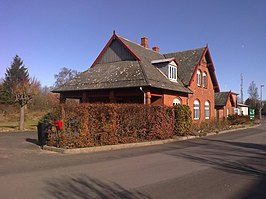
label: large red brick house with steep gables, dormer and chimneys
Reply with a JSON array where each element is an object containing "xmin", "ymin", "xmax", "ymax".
[{"xmin": 53, "ymin": 33, "xmax": 236, "ymax": 121}]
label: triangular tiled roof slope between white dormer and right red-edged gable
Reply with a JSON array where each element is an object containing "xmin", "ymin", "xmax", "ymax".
[{"xmin": 164, "ymin": 47, "xmax": 206, "ymax": 86}]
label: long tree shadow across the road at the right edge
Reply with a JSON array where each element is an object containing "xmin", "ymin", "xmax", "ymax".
[{"xmin": 166, "ymin": 139, "xmax": 266, "ymax": 199}]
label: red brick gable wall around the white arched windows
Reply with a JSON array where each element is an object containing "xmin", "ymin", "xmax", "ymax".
[{"xmin": 188, "ymin": 62, "xmax": 216, "ymax": 122}]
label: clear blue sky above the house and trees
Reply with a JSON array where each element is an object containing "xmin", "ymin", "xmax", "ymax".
[{"xmin": 0, "ymin": 0, "xmax": 266, "ymax": 99}]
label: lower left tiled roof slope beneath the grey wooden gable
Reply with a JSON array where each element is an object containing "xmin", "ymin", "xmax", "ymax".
[{"xmin": 54, "ymin": 61, "xmax": 147, "ymax": 92}]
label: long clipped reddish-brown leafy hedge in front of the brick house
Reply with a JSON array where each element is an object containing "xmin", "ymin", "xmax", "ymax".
[{"xmin": 48, "ymin": 103, "xmax": 174, "ymax": 148}]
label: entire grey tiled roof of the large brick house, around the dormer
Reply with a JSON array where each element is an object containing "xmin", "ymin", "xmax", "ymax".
[{"xmin": 54, "ymin": 35, "xmax": 201, "ymax": 93}]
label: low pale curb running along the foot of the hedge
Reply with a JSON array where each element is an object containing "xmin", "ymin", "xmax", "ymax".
[{"xmin": 42, "ymin": 124, "xmax": 260, "ymax": 154}]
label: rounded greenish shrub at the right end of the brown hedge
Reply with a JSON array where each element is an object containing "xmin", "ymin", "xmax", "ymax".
[{"xmin": 174, "ymin": 104, "xmax": 192, "ymax": 136}]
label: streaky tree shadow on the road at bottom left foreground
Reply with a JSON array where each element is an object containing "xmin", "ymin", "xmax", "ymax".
[{"xmin": 45, "ymin": 176, "xmax": 150, "ymax": 199}]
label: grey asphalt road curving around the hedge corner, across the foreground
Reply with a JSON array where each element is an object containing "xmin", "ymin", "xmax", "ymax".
[{"xmin": 0, "ymin": 122, "xmax": 266, "ymax": 199}]
